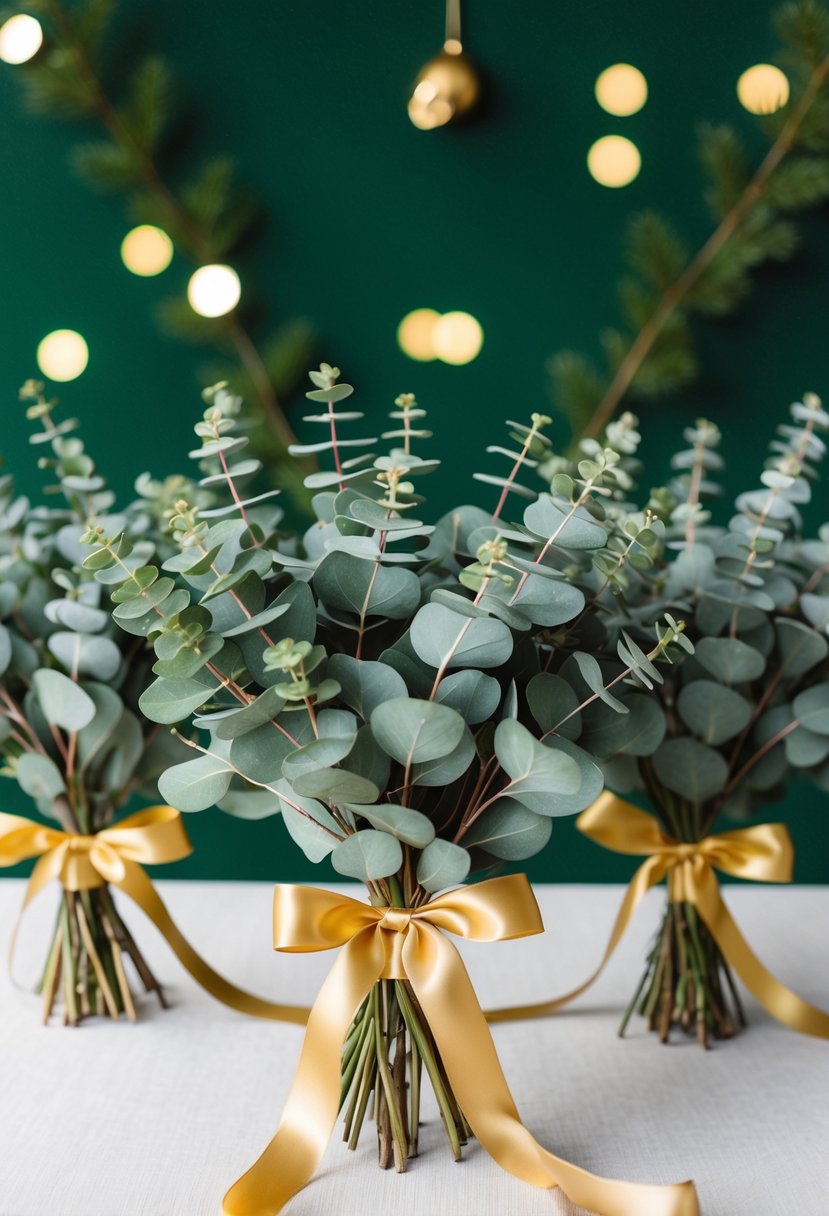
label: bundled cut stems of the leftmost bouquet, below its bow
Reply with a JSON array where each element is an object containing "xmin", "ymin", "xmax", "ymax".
[{"xmin": 39, "ymin": 886, "xmax": 167, "ymax": 1026}]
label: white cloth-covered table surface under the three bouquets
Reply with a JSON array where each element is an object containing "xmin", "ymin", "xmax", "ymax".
[{"xmin": 0, "ymin": 879, "xmax": 829, "ymax": 1216}]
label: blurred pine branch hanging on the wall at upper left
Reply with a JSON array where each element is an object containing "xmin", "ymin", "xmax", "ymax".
[{"xmin": 14, "ymin": 0, "xmax": 308, "ymax": 497}]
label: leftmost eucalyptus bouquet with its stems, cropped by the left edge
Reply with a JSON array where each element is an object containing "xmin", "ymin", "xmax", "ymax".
[{"xmin": 0, "ymin": 381, "xmax": 190, "ymax": 1025}]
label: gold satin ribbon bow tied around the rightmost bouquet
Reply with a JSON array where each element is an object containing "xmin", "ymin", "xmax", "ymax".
[{"xmin": 486, "ymin": 792, "xmax": 829, "ymax": 1038}]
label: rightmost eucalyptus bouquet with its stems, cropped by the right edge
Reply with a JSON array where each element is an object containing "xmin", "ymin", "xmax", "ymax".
[{"xmin": 534, "ymin": 394, "xmax": 829, "ymax": 1045}]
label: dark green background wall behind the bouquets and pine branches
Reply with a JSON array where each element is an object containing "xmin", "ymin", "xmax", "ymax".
[{"xmin": 0, "ymin": 0, "xmax": 829, "ymax": 882}]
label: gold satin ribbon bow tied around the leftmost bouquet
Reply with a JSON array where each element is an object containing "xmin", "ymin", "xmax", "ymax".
[{"xmin": 0, "ymin": 806, "xmax": 309, "ymax": 1025}]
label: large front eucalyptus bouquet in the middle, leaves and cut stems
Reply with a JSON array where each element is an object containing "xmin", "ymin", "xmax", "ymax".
[{"xmin": 85, "ymin": 364, "xmax": 682, "ymax": 1170}]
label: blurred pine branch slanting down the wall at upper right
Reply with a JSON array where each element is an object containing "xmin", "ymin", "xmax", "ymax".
[{"xmin": 548, "ymin": 0, "xmax": 829, "ymax": 437}]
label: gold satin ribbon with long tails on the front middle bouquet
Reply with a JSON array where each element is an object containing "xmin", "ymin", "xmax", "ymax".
[{"xmin": 222, "ymin": 874, "xmax": 699, "ymax": 1216}]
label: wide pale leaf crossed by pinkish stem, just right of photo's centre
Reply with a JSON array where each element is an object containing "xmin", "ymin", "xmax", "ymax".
[{"xmin": 410, "ymin": 603, "xmax": 513, "ymax": 670}]
